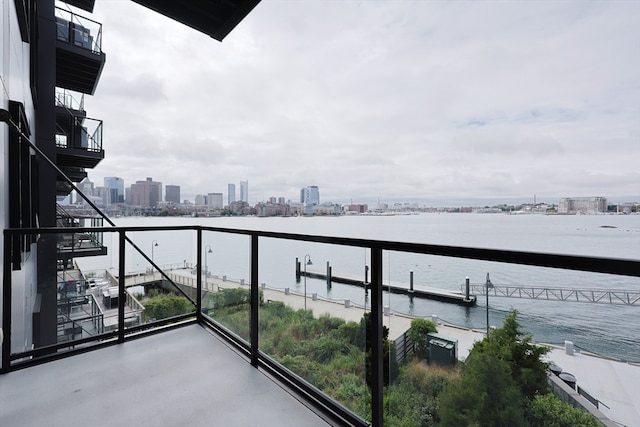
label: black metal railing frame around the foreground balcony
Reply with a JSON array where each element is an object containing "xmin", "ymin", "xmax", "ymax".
[{"xmin": 1, "ymin": 226, "xmax": 640, "ymax": 426}]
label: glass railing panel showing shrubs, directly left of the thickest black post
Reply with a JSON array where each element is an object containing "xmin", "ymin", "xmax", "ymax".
[{"xmin": 259, "ymin": 238, "xmax": 370, "ymax": 419}]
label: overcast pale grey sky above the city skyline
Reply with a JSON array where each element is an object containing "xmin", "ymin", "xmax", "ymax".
[{"xmin": 85, "ymin": 0, "xmax": 640, "ymax": 205}]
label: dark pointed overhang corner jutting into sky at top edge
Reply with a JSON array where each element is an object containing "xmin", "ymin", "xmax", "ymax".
[{"xmin": 133, "ymin": 0, "xmax": 260, "ymax": 41}]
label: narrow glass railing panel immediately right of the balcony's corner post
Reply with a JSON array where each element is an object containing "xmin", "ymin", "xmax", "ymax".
[{"xmin": 201, "ymin": 231, "xmax": 251, "ymax": 342}]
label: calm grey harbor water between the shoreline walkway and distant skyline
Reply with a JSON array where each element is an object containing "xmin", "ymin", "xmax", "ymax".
[{"xmin": 77, "ymin": 213, "xmax": 640, "ymax": 362}]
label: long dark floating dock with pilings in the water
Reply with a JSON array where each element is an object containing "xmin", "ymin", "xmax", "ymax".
[{"xmin": 296, "ymin": 259, "xmax": 476, "ymax": 306}]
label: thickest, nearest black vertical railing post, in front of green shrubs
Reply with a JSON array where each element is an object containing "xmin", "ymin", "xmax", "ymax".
[{"xmin": 371, "ymin": 248, "xmax": 384, "ymax": 426}]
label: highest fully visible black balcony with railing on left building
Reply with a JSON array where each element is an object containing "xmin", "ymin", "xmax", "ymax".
[{"xmin": 56, "ymin": 7, "xmax": 106, "ymax": 95}]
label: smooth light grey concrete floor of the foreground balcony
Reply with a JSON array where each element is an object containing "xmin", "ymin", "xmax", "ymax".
[{"xmin": 0, "ymin": 325, "xmax": 336, "ymax": 427}]
